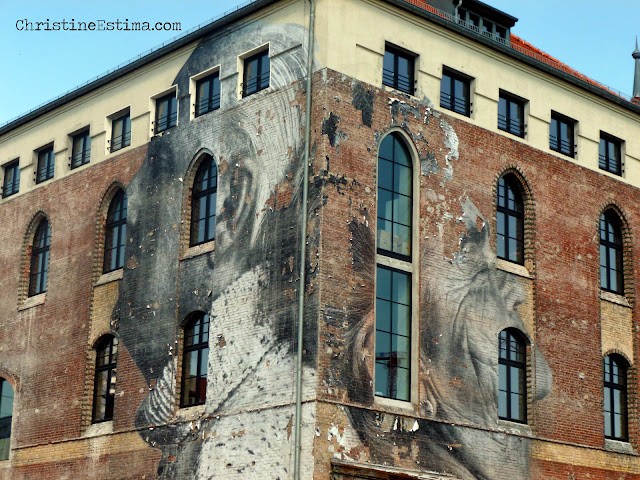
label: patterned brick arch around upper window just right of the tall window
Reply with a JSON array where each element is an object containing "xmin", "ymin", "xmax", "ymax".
[{"xmin": 491, "ymin": 164, "xmax": 536, "ymax": 276}]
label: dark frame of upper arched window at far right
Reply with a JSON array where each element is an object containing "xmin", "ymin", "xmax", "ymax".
[{"xmin": 598, "ymin": 209, "xmax": 625, "ymax": 295}]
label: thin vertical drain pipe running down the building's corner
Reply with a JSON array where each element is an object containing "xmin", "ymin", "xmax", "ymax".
[{"xmin": 293, "ymin": 0, "xmax": 316, "ymax": 480}]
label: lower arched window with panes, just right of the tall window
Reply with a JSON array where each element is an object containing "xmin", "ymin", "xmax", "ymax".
[{"xmin": 498, "ymin": 329, "xmax": 527, "ymax": 423}]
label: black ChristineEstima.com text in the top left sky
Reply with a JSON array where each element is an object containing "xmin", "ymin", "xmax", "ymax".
[{"xmin": 16, "ymin": 18, "xmax": 182, "ymax": 32}]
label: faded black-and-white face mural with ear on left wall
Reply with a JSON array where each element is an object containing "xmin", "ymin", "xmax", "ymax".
[{"xmin": 114, "ymin": 22, "xmax": 315, "ymax": 479}]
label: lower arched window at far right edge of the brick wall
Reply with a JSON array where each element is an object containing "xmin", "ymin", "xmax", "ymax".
[{"xmin": 604, "ymin": 355, "xmax": 628, "ymax": 440}]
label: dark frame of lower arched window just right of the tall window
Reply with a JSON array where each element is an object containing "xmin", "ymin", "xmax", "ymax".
[{"xmin": 497, "ymin": 328, "xmax": 528, "ymax": 424}]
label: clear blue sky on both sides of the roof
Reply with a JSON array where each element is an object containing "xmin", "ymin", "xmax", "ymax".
[{"xmin": 0, "ymin": 0, "xmax": 640, "ymax": 124}]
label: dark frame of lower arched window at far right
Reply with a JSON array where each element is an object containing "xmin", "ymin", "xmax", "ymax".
[{"xmin": 602, "ymin": 354, "xmax": 629, "ymax": 442}]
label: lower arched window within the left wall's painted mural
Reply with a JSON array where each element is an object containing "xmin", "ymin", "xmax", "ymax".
[{"xmin": 180, "ymin": 313, "xmax": 209, "ymax": 407}]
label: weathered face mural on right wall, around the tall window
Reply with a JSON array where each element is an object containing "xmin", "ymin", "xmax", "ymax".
[{"xmin": 343, "ymin": 122, "xmax": 551, "ymax": 480}]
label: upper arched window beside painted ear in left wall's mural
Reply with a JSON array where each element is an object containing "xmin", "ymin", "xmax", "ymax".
[{"xmin": 189, "ymin": 155, "xmax": 218, "ymax": 246}]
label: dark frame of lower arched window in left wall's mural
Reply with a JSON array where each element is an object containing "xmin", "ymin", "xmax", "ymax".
[{"xmin": 180, "ymin": 312, "xmax": 211, "ymax": 408}]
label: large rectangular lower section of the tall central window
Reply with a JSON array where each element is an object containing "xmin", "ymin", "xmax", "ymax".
[{"xmin": 375, "ymin": 265, "xmax": 411, "ymax": 401}]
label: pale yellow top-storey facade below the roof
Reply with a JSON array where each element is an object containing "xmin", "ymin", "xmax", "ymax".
[{"xmin": 0, "ymin": 0, "xmax": 640, "ymax": 202}]
